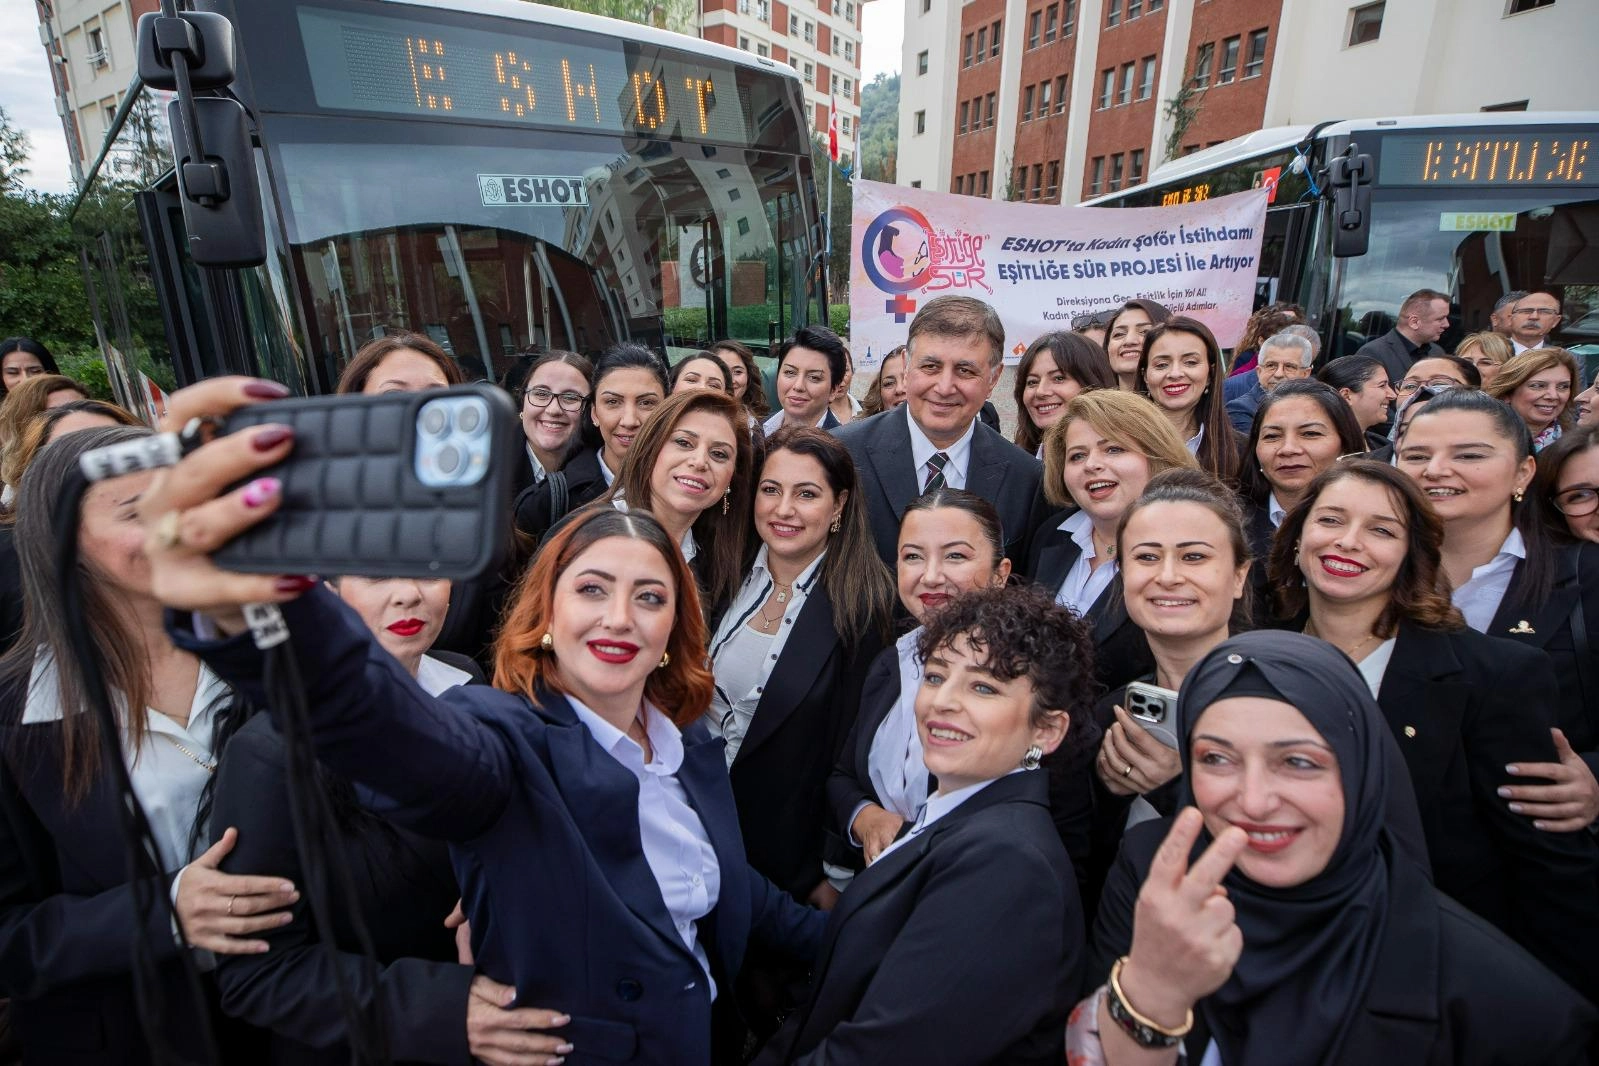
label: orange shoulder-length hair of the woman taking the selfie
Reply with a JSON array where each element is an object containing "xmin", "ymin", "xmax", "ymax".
[{"xmin": 494, "ymin": 502, "xmax": 716, "ymax": 729}]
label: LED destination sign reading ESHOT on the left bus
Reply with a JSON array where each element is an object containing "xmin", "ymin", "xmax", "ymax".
[{"xmin": 299, "ymin": 8, "xmax": 748, "ymax": 142}]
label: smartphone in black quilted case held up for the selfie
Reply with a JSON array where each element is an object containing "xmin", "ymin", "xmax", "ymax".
[{"xmin": 214, "ymin": 382, "xmax": 526, "ymax": 580}]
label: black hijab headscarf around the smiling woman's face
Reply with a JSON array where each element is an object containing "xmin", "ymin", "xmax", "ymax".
[{"xmin": 1177, "ymin": 631, "xmax": 1420, "ymax": 1066}]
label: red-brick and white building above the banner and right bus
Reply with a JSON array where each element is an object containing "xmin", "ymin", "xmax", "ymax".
[{"xmin": 899, "ymin": 0, "xmax": 1599, "ymax": 203}]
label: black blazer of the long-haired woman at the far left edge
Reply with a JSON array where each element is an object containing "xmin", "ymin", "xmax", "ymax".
[{"xmin": 0, "ymin": 681, "xmax": 261, "ymax": 1066}]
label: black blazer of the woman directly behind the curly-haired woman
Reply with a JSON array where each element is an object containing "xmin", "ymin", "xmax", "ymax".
[{"xmin": 827, "ymin": 644, "xmax": 1094, "ymax": 889}]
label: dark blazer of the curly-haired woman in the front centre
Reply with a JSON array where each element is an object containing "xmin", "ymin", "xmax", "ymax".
[{"xmin": 755, "ymin": 774, "xmax": 1084, "ymax": 1066}]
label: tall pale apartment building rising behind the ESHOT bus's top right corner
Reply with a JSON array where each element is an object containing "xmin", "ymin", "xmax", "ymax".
[{"xmin": 700, "ymin": 0, "xmax": 869, "ymax": 155}]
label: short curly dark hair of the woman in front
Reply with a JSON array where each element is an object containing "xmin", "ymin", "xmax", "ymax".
[{"xmin": 916, "ymin": 585, "xmax": 1099, "ymax": 746}]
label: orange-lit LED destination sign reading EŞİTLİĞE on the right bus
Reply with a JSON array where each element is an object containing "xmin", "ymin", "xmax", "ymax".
[{"xmin": 1377, "ymin": 133, "xmax": 1599, "ymax": 189}]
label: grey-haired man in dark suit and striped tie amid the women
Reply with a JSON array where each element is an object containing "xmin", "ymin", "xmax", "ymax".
[{"xmin": 838, "ymin": 296, "xmax": 1047, "ymax": 567}]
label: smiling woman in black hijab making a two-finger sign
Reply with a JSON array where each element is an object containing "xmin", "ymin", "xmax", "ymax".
[{"xmin": 1068, "ymin": 631, "xmax": 1599, "ymax": 1066}]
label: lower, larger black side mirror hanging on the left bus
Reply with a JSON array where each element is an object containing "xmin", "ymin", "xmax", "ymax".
[{"xmin": 168, "ymin": 96, "xmax": 267, "ymax": 267}]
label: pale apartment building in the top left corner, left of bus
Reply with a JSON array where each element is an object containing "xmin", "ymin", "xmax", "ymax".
[{"xmin": 34, "ymin": 0, "xmax": 161, "ymax": 182}]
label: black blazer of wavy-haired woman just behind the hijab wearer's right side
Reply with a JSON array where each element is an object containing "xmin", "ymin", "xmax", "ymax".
[{"xmin": 1377, "ymin": 622, "xmax": 1599, "ymax": 999}]
